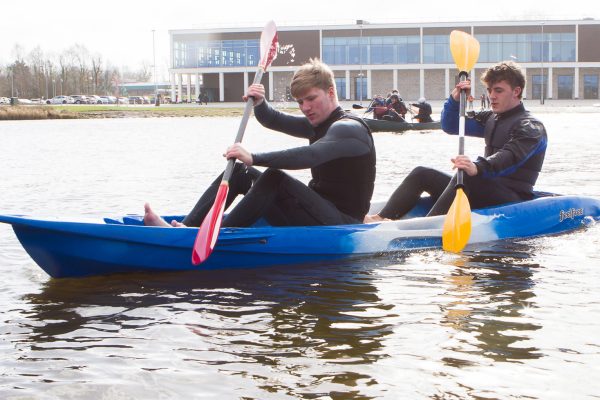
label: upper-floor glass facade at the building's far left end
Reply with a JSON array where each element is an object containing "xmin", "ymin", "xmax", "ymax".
[{"xmin": 173, "ymin": 39, "xmax": 260, "ymax": 68}]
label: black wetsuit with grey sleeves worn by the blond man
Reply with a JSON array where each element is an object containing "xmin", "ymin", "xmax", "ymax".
[{"xmin": 183, "ymin": 101, "xmax": 375, "ymax": 226}]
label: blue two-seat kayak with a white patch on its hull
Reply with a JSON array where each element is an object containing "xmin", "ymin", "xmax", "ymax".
[{"xmin": 0, "ymin": 196, "xmax": 600, "ymax": 277}]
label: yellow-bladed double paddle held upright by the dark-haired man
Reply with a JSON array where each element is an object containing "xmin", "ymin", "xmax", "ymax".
[{"xmin": 442, "ymin": 31, "xmax": 479, "ymax": 253}]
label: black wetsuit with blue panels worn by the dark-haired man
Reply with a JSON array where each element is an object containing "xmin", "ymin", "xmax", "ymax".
[{"xmin": 379, "ymin": 96, "xmax": 548, "ymax": 219}]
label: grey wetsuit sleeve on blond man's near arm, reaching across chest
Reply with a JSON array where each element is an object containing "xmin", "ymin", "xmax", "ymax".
[{"xmin": 252, "ymin": 119, "xmax": 374, "ymax": 170}]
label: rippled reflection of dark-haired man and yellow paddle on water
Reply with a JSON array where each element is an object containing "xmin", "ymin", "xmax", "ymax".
[{"xmin": 443, "ymin": 241, "xmax": 542, "ymax": 367}]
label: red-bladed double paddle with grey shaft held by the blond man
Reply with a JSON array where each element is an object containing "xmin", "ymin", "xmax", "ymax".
[{"xmin": 192, "ymin": 21, "xmax": 278, "ymax": 265}]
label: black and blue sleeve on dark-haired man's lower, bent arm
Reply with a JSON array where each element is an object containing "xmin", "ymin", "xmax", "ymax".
[{"xmin": 475, "ymin": 119, "xmax": 547, "ymax": 178}]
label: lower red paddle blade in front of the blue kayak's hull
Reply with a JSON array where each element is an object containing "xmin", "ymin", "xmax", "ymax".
[{"xmin": 192, "ymin": 182, "xmax": 229, "ymax": 265}]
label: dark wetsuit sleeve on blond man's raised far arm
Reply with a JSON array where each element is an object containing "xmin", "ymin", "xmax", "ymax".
[{"xmin": 254, "ymin": 100, "xmax": 315, "ymax": 139}]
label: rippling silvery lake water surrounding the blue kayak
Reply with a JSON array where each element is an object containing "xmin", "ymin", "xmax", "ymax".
[{"xmin": 0, "ymin": 113, "xmax": 600, "ymax": 399}]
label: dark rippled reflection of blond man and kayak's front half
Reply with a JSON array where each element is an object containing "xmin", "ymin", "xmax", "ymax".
[{"xmin": 21, "ymin": 264, "xmax": 393, "ymax": 393}]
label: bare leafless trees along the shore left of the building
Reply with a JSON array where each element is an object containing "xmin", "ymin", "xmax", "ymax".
[{"xmin": 0, "ymin": 44, "xmax": 151, "ymax": 99}]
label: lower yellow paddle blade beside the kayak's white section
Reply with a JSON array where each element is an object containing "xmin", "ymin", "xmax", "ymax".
[{"xmin": 442, "ymin": 188, "xmax": 471, "ymax": 253}]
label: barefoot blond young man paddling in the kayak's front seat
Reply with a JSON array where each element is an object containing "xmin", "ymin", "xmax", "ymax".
[{"xmin": 144, "ymin": 59, "xmax": 375, "ymax": 227}]
